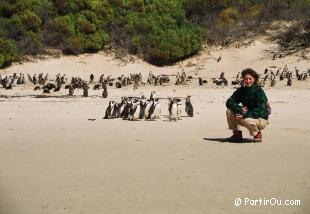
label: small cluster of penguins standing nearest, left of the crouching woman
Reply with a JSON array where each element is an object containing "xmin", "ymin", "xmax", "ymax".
[{"xmin": 103, "ymin": 91, "xmax": 194, "ymax": 121}]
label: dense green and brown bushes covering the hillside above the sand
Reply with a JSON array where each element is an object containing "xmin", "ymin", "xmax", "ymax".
[{"xmin": 0, "ymin": 0, "xmax": 310, "ymax": 67}]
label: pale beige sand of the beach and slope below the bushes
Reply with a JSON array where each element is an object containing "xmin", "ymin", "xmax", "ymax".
[{"xmin": 0, "ymin": 36, "xmax": 310, "ymax": 214}]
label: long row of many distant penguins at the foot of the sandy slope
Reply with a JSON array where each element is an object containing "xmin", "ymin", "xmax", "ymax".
[{"xmin": 0, "ymin": 65, "xmax": 310, "ymax": 95}]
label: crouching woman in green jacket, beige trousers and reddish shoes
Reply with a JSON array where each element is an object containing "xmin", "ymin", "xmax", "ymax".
[{"xmin": 226, "ymin": 68, "xmax": 269, "ymax": 142}]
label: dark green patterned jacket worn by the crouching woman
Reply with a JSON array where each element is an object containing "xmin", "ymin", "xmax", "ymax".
[{"xmin": 226, "ymin": 85, "xmax": 269, "ymax": 120}]
